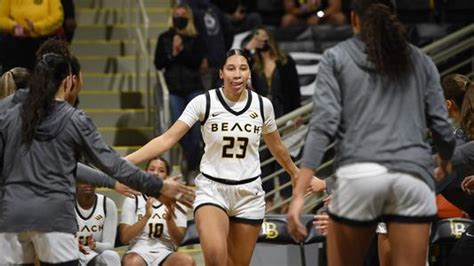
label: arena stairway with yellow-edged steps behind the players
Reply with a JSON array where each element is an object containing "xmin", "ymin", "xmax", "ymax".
[{"xmin": 71, "ymin": 0, "xmax": 170, "ymax": 222}]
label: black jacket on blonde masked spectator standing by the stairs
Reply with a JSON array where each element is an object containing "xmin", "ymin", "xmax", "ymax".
[{"xmin": 154, "ymin": 29, "xmax": 206, "ymax": 96}]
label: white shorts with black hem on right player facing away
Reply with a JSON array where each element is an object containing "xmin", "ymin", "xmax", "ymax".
[{"xmin": 329, "ymin": 163, "xmax": 437, "ymax": 225}]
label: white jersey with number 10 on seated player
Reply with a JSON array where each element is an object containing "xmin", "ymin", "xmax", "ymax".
[{"xmin": 126, "ymin": 194, "xmax": 187, "ymax": 250}]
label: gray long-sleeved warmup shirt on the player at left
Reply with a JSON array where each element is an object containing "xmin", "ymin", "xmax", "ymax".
[{"xmin": 0, "ymin": 101, "xmax": 162, "ymax": 233}]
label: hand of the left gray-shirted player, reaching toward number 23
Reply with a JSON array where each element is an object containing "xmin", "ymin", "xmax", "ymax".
[{"xmin": 160, "ymin": 176, "xmax": 195, "ymax": 208}]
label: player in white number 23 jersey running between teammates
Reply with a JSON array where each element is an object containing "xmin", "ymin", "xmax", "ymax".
[{"xmin": 127, "ymin": 49, "xmax": 324, "ymax": 266}]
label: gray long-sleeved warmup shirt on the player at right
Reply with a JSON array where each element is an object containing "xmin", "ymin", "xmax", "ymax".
[{"xmin": 301, "ymin": 36, "xmax": 455, "ymax": 189}]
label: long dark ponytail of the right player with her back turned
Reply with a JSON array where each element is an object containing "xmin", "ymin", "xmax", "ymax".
[{"xmin": 352, "ymin": 0, "xmax": 410, "ymax": 77}]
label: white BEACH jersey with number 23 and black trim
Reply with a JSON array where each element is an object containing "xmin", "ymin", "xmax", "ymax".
[{"xmin": 201, "ymin": 89, "xmax": 265, "ymax": 180}]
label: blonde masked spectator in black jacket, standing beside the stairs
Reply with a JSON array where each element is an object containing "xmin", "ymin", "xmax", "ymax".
[{"xmin": 155, "ymin": 4, "xmax": 206, "ymax": 185}]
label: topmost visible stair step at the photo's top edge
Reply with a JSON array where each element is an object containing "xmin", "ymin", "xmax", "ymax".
[{"xmin": 74, "ymin": 0, "xmax": 171, "ymax": 8}]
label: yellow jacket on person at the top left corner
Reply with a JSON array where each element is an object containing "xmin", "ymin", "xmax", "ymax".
[{"xmin": 0, "ymin": 0, "xmax": 63, "ymax": 37}]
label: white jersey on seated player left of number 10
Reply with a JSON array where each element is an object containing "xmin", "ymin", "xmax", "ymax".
[{"xmin": 76, "ymin": 194, "xmax": 107, "ymax": 246}]
